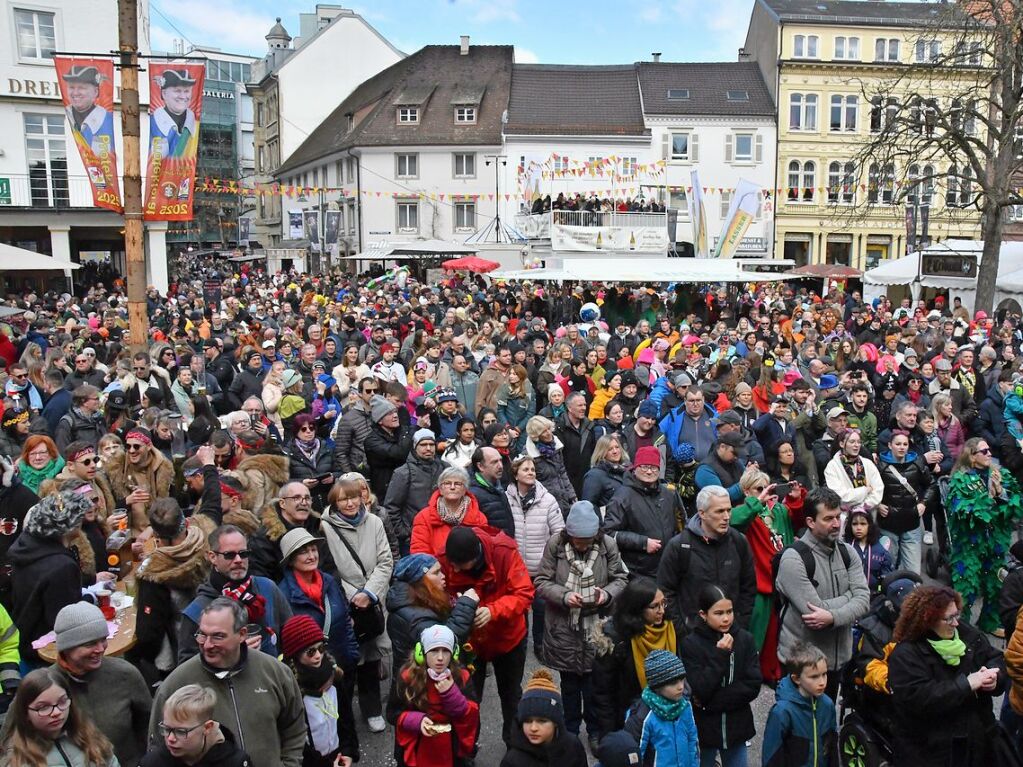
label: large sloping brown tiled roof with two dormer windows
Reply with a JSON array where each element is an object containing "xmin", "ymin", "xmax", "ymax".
[{"xmin": 276, "ymin": 45, "xmax": 515, "ymax": 176}]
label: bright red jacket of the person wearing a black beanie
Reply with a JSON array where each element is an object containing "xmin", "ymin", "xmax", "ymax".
[{"xmin": 438, "ymin": 528, "xmax": 534, "ymax": 661}]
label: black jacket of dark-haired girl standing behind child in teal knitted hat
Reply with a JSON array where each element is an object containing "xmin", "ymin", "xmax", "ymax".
[{"xmin": 678, "ymin": 621, "xmax": 763, "ymax": 749}]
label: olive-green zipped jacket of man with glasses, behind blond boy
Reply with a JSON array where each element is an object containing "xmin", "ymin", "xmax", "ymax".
[{"xmin": 149, "ymin": 644, "xmax": 306, "ymax": 767}]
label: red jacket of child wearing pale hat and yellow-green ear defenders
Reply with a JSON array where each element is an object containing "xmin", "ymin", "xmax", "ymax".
[{"xmin": 394, "ymin": 669, "xmax": 480, "ymax": 767}]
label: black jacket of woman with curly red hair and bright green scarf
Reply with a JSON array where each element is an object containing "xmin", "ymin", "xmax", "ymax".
[{"xmin": 888, "ymin": 623, "xmax": 1006, "ymax": 767}]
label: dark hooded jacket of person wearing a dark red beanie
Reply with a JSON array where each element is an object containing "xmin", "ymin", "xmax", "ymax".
[{"xmin": 602, "ymin": 471, "xmax": 680, "ymax": 578}]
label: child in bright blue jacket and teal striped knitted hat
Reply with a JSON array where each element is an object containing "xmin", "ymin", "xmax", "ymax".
[{"xmin": 625, "ymin": 649, "xmax": 700, "ymax": 767}]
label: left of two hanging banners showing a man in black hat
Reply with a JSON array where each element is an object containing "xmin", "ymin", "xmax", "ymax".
[{"xmin": 53, "ymin": 56, "xmax": 124, "ymax": 213}]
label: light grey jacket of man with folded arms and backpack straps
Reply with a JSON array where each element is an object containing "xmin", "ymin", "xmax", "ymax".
[{"xmin": 774, "ymin": 530, "xmax": 871, "ymax": 671}]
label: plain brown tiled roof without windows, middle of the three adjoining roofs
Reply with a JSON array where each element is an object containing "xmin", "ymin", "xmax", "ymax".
[{"xmin": 504, "ymin": 64, "xmax": 650, "ymax": 136}]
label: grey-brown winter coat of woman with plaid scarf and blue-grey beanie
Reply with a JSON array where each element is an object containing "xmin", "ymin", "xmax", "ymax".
[{"xmin": 534, "ymin": 532, "xmax": 628, "ymax": 674}]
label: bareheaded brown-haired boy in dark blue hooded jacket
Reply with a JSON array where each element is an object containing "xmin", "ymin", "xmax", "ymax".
[{"xmin": 762, "ymin": 642, "xmax": 839, "ymax": 767}]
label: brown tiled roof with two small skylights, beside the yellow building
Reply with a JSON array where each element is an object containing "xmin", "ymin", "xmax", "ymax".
[{"xmin": 636, "ymin": 61, "xmax": 774, "ymax": 117}]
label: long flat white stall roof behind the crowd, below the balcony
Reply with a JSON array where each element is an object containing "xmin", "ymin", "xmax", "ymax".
[{"xmin": 490, "ymin": 259, "xmax": 777, "ymax": 282}]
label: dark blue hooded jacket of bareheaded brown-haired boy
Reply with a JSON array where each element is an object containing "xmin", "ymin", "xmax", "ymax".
[{"xmin": 763, "ymin": 676, "xmax": 834, "ymax": 767}]
